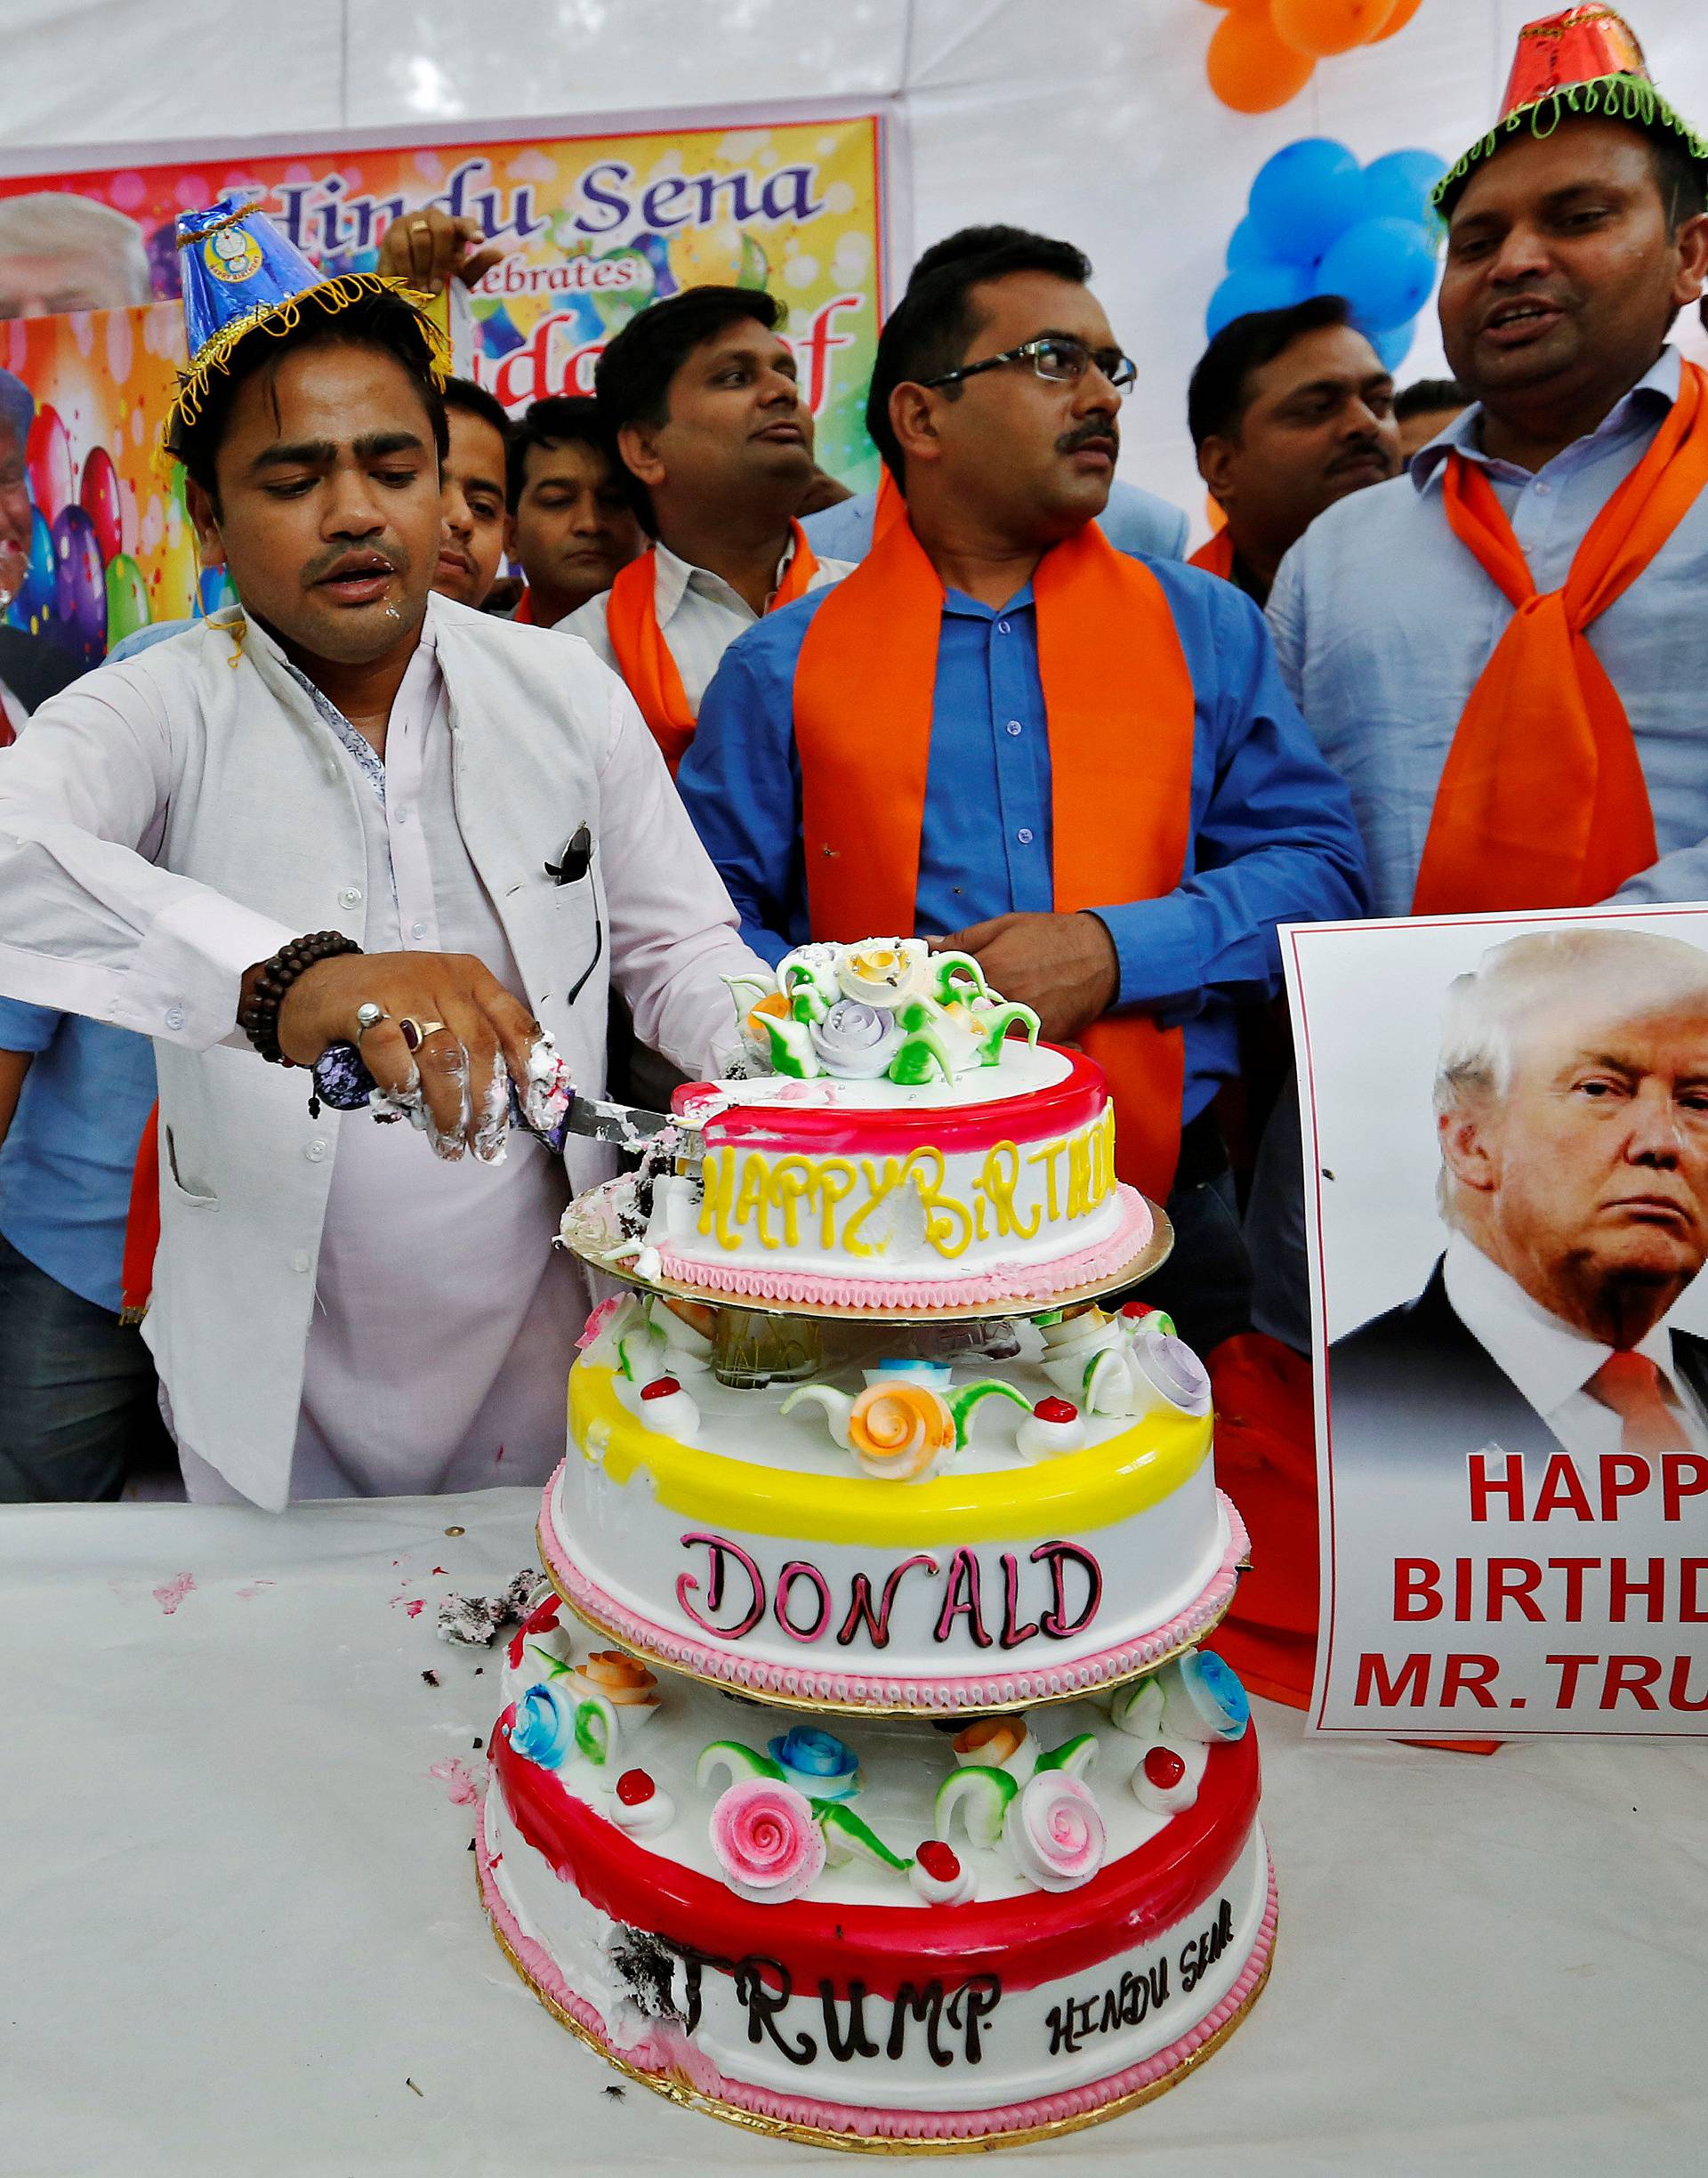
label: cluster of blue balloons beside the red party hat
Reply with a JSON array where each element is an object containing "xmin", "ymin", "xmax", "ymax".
[{"xmin": 1204, "ymin": 137, "xmax": 1446, "ymax": 370}]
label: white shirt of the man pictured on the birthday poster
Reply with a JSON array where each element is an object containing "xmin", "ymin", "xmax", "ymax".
[{"xmin": 1442, "ymin": 1233, "xmax": 1708, "ymax": 1459}]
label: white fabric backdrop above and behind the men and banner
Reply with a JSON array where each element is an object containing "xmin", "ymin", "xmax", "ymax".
[{"xmin": 0, "ymin": 0, "xmax": 1708, "ymax": 523}]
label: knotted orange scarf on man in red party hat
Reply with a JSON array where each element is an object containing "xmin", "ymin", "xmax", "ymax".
[{"xmin": 1412, "ymin": 364, "xmax": 1708, "ymax": 915}]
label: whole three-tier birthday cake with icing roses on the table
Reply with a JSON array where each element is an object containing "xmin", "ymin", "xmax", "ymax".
[{"xmin": 477, "ymin": 941, "xmax": 1275, "ymax": 2148}]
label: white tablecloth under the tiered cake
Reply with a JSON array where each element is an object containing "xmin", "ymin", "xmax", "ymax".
[{"xmin": 0, "ymin": 1489, "xmax": 1708, "ymax": 2178}]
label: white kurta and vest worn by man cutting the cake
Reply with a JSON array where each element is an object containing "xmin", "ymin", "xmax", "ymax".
[{"xmin": 0, "ymin": 599, "xmax": 753, "ymax": 1505}]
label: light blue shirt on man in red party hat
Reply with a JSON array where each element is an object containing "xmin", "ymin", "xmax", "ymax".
[{"xmin": 1268, "ymin": 349, "xmax": 1708, "ymax": 915}]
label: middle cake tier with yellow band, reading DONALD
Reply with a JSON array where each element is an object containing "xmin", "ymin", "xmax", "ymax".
[{"xmin": 540, "ymin": 1298, "xmax": 1246, "ymax": 1714}]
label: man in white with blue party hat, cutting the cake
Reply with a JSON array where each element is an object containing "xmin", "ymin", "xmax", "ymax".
[{"xmin": 0, "ymin": 203, "xmax": 752, "ymax": 1505}]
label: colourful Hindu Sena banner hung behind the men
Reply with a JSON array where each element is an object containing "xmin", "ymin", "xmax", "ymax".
[{"xmin": 0, "ymin": 111, "xmax": 889, "ymax": 490}]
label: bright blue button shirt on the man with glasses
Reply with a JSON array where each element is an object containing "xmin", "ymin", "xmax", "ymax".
[{"xmin": 678, "ymin": 562, "xmax": 1364, "ymax": 1119}]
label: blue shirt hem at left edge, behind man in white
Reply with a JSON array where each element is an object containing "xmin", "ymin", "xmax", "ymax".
[{"xmin": 0, "ymin": 997, "xmax": 155, "ymax": 1316}]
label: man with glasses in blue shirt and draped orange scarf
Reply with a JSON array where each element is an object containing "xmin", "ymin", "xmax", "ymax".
[{"xmin": 680, "ymin": 230, "xmax": 1364, "ymax": 1343}]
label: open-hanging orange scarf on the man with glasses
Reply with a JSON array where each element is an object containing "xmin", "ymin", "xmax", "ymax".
[{"xmin": 795, "ymin": 507, "xmax": 1194, "ymax": 1200}]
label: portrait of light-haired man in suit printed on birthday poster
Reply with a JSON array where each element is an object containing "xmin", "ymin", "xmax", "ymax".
[{"xmin": 1329, "ymin": 925, "xmax": 1708, "ymax": 1477}]
